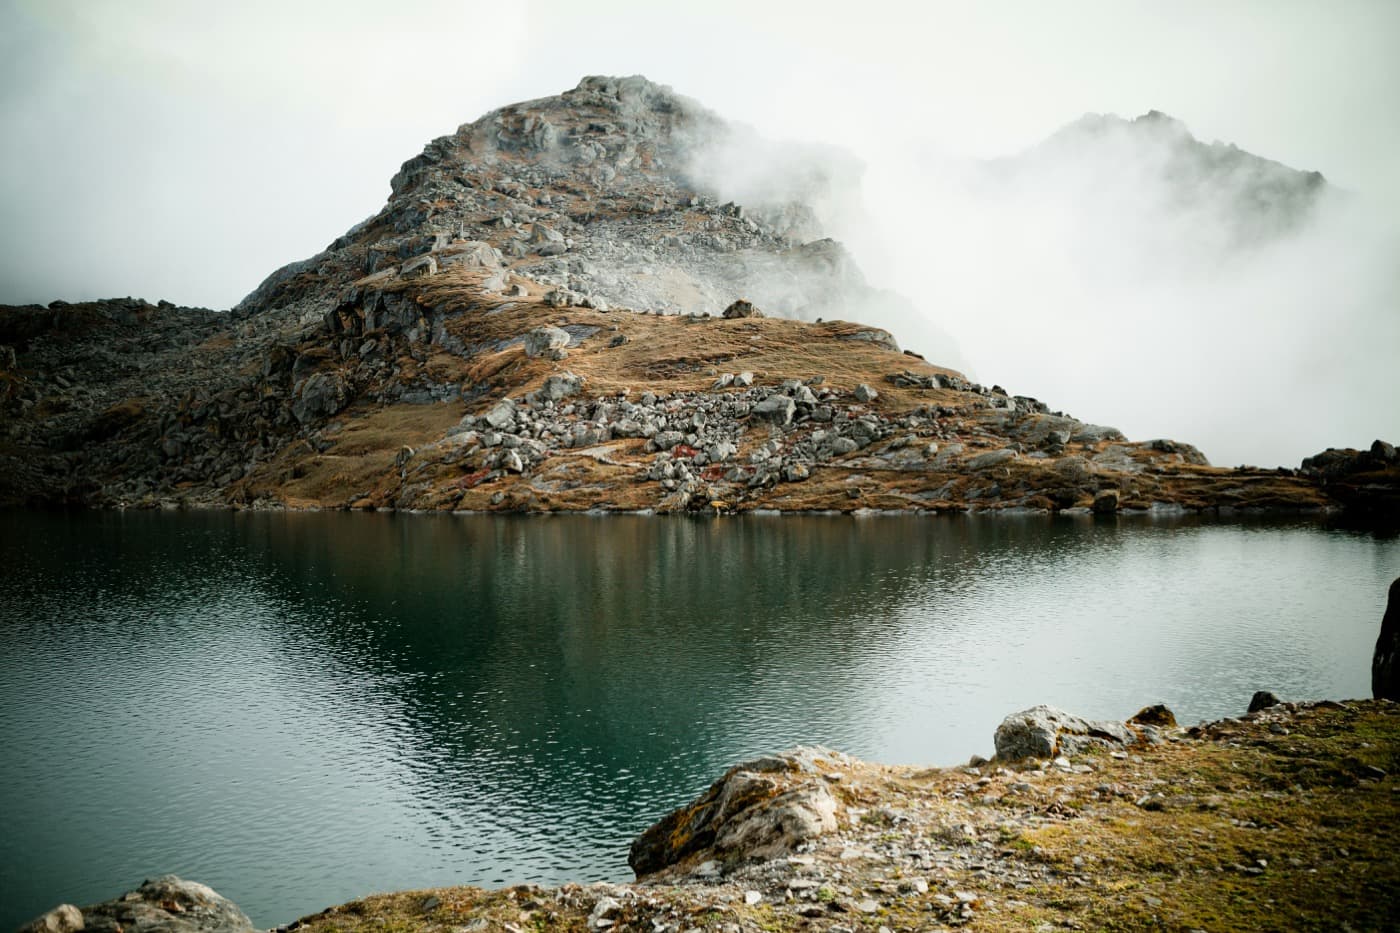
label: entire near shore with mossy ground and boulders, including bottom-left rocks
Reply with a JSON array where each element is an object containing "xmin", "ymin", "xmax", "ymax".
[{"xmin": 24, "ymin": 693, "xmax": 1400, "ymax": 933}]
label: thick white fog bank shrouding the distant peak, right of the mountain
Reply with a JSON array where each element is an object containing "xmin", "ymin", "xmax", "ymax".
[{"xmin": 691, "ymin": 111, "xmax": 1400, "ymax": 467}]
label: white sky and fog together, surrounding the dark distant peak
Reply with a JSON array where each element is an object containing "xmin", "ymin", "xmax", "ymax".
[{"xmin": 0, "ymin": 0, "xmax": 1400, "ymax": 465}]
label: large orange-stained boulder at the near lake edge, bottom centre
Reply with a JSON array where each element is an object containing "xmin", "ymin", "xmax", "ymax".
[{"xmin": 627, "ymin": 748, "xmax": 848, "ymax": 878}]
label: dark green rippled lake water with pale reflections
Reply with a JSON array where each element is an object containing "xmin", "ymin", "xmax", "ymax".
[{"xmin": 0, "ymin": 513, "xmax": 1400, "ymax": 930}]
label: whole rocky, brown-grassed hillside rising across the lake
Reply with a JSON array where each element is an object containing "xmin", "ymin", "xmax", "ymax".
[{"xmin": 0, "ymin": 77, "xmax": 1400, "ymax": 513}]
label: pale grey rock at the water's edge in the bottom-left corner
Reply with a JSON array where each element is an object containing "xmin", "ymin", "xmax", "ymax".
[{"xmin": 20, "ymin": 874, "xmax": 253, "ymax": 933}]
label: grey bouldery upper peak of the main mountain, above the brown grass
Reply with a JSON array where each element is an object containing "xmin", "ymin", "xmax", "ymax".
[{"xmin": 235, "ymin": 76, "xmax": 873, "ymax": 334}]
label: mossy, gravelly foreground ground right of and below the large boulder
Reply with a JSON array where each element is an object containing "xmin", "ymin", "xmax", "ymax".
[{"xmin": 278, "ymin": 700, "xmax": 1400, "ymax": 933}]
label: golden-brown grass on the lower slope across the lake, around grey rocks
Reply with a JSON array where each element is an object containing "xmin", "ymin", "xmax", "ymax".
[{"xmin": 237, "ymin": 272, "xmax": 1327, "ymax": 511}]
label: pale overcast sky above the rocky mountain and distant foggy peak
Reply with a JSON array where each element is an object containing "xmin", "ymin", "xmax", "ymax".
[{"xmin": 0, "ymin": 0, "xmax": 1400, "ymax": 465}]
